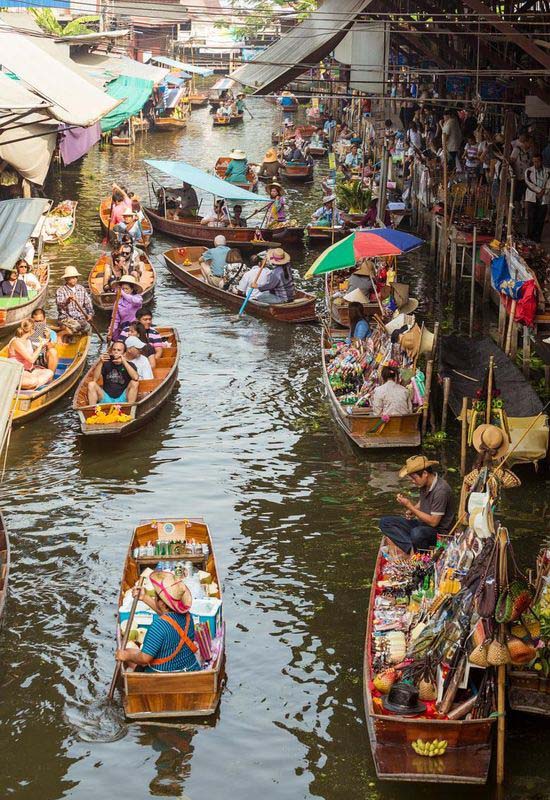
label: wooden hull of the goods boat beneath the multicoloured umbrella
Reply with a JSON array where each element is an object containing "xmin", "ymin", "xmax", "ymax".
[{"xmin": 321, "ymin": 331, "xmax": 421, "ymax": 450}]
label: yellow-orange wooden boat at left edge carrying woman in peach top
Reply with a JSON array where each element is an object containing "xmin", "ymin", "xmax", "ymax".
[{"xmin": 0, "ymin": 334, "xmax": 91, "ymax": 425}]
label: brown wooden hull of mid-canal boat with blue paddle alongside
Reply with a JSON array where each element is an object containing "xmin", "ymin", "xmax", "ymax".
[{"xmin": 164, "ymin": 247, "xmax": 317, "ymax": 323}]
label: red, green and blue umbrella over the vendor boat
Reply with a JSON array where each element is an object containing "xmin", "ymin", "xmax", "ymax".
[{"xmin": 306, "ymin": 228, "xmax": 424, "ymax": 278}]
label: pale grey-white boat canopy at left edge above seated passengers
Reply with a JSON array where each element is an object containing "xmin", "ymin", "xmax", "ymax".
[{"xmin": 0, "ymin": 197, "xmax": 51, "ymax": 269}]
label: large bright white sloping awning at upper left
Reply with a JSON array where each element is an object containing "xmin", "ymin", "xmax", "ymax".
[{"xmin": 0, "ymin": 22, "xmax": 119, "ymax": 126}]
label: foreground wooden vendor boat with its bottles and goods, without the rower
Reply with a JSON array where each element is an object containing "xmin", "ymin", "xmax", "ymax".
[{"xmin": 117, "ymin": 517, "xmax": 226, "ymax": 720}]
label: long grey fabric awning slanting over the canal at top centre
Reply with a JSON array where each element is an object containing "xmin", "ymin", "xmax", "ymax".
[{"xmin": 231, "ymin": 0, "xmax": 371, "ymax": 94}]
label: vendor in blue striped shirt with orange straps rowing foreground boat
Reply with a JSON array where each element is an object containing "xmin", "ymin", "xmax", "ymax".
[{"xmin": 116, "ymin": 571, "xmax": 200, "ymax": 672}]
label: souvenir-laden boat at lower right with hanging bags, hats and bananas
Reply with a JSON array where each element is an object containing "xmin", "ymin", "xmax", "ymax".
[{"xmin": 364, "ymin": 424, "xmax": 533, "ymax": 784}]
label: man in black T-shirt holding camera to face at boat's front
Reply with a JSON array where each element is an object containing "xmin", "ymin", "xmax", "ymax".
[{"xmin": 88, "ymin": 342, "xmax": 139, "ymax": 406}]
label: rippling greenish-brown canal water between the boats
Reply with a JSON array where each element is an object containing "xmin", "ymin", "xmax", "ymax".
[{"xmin": 0, "ymin": 100, "xmax": 550, "ymax": 800}]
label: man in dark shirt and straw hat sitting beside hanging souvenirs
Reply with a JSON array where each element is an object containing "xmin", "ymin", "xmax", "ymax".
[{"xmin": 379, "ymin": 456, "xmax": 454, "ymax": 553}]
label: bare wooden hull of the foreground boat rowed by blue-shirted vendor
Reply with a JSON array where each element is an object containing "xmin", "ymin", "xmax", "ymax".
[{"xmin": 117, "ymin": 517, "xmax": 225, "ymax": 719}]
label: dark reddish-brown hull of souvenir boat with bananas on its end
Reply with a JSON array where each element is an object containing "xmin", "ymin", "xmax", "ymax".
[{"xmin": 363, "ymin": 540, "xmax": 496, "ymax": 784}]
